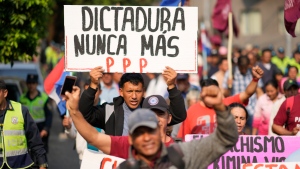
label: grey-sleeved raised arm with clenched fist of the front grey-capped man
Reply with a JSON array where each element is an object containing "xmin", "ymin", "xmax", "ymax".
[{"xmin": 179, "ymin": 86, "xmax": 239, "ymax": 169}]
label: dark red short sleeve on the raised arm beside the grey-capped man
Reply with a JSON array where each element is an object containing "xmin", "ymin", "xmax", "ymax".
[{"xmin": 109, "ymin": 136, "xmax": 130, "ymax": 159}]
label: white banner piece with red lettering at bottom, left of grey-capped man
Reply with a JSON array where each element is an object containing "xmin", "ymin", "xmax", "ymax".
[{"xmin": 80, "ymin": 149, "xmax": 125, "ymax": 169}]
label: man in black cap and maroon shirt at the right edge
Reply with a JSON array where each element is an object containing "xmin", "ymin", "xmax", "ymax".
[{"xmin": 272, "ymin": 80, "xmax": 300, "ymax": 136}]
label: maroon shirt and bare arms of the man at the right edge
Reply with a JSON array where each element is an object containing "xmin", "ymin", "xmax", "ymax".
[{"xmin": 272, "ymin": 93, "xmax": 300, "ymax": 136}]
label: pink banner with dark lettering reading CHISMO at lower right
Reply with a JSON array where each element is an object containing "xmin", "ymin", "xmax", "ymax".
[{"xmin": 185, "ymin": 135, "xmax": 300, "ymax": 169}]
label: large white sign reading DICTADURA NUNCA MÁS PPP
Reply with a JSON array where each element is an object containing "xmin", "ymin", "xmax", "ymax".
[{"xmin": 64, "ymin": 5, "xmax": 198, "ymax": 73}]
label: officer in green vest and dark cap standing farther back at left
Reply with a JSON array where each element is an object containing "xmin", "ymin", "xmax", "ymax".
[{"xmin": 20, "ymin": 74, "xmax": 52, "ymax": 155}]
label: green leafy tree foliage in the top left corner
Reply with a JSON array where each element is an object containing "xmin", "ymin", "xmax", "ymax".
[{"xmin": 0, "ymin": 0, "xmax": 52, "ymax": 64}]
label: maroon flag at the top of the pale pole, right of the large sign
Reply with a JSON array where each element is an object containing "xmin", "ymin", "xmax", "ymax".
[{"xmin": 212, "ymin": 0, "xmax": 239, "ymax": 36}]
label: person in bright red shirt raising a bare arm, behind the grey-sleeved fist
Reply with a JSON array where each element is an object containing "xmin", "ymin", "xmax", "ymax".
[{"xmin": 177, "ymin": 67, "xmax": 263, "ymax": 140}]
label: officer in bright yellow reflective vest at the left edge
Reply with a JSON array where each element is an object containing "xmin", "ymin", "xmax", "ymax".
[{"xmin": 0, "ymin": 80, "xmax": 48, "ymax": 169}]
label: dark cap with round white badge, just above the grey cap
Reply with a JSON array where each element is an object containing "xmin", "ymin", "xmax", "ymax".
[{"xmin": 142, "ymin": 95, "xmax": 169, "ymax": 112}]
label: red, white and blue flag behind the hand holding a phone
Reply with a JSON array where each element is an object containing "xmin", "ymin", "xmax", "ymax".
[{"xmin": 44, "ymin": 57, "xmax": 70, "ymax": 115}]
